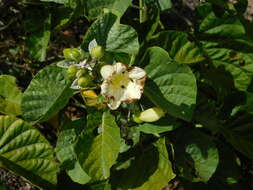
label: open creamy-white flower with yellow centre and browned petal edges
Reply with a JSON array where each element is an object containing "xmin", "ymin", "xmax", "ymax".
[{"xmin": 100, "ymin": 63, "xmax": 146, "ymax": 110}]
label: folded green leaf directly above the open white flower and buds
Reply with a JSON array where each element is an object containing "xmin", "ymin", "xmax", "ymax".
[{"xmin": 82, "ymin": 13, "xmax": 139, "ymax": 54}]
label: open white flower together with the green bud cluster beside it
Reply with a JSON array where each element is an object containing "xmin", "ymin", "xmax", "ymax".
[{"xmin": 59, "ymin": 39, "xmax": 154, "ymax": 113}]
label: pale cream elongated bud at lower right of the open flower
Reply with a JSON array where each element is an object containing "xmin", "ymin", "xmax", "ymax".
[{"xmin": 135, "ymin": 107, "xmax": 165, "ymax": 122}]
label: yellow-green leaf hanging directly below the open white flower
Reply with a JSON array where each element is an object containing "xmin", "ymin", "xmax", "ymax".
[{"xmin": 76, "ymin": 112, "xmax": 120, "ymax": 181}]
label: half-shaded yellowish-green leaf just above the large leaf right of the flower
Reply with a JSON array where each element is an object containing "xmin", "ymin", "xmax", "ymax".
[{"xmin": 151, "ymin": 31, "xmax": 205, "ymax": 64}]
